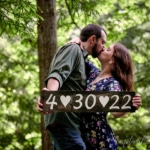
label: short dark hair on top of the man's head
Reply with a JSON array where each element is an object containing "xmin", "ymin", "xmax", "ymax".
[{"xmin": 80, "ymin": 24, "xmax": 107, "ymax": 42}]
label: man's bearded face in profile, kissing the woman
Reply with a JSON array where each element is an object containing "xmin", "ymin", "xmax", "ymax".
[{"xmin": 92, "ymin": 30, "xmax": 107, "ymax": 58}]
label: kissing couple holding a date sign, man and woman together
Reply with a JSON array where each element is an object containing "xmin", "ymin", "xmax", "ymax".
[{"xmin": 38, "ymin": 24, "xmax": 141, "ymax": 150}]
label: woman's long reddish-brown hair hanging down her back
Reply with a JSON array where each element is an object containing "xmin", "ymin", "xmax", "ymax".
[{"xmin": 112, "ymin": 43, "xmax": 133, "ymax": 91}]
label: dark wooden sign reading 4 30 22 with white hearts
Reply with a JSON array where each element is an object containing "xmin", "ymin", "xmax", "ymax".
[{"xmin": 41, "ymin": 91, "xmax": 135, "ymax": 112}]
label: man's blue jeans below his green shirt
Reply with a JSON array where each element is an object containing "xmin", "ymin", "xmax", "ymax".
[{"xmin": 48, "ymin": 127, "xmax": 86, "ymax": 150}]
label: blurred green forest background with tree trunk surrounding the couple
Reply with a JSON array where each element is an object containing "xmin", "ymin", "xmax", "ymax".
[{"xmin": 0, "ymin": 0, "xmax": 150, "ymax": 150}]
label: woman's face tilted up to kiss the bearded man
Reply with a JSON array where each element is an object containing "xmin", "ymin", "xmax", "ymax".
[{"xmin": 98, "ymin": 45, "xmax": 114, "ymax": 63}]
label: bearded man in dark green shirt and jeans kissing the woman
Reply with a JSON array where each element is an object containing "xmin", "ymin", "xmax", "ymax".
[{"xmin": 38, "ymin": 24, "xmax": 106, "ymax": 150}]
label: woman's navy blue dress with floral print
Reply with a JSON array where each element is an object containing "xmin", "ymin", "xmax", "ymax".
[{"xmin": 83, "ymin": 62, "xmax": 121, "ymax": 150}]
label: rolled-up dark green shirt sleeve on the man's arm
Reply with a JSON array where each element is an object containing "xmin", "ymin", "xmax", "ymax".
[{"xmin": 45, "ymin": 44, "xmax": 81, "ymax": 88}]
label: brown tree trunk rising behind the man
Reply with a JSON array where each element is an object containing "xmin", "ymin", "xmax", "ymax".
[{"xmin": 37, "ymin": 0, "xmax": 57, "ymax": 150}]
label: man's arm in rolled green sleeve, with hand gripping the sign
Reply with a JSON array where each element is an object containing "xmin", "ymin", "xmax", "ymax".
[{"xmin": 37, "ymin": 45, "xmax": 80, "ymax": 113}]
